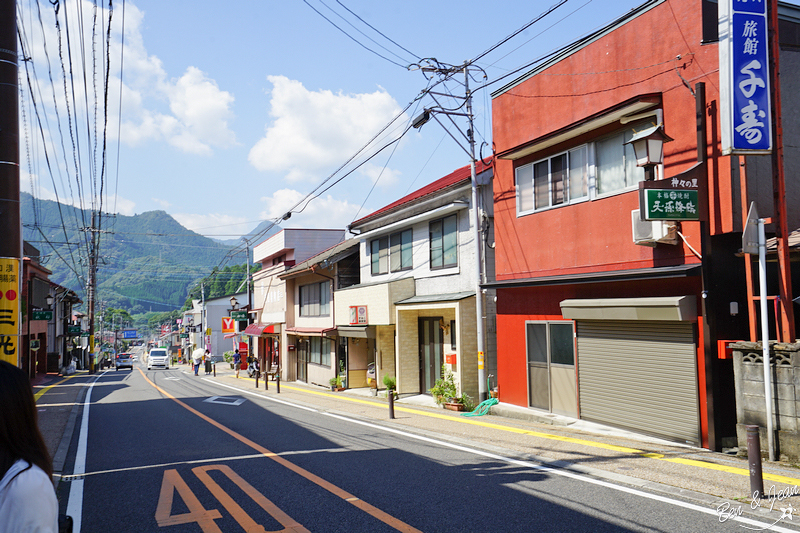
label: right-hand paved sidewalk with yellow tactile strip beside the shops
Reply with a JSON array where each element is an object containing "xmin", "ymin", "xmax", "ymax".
[{"xmin": 209, "ymin": 371, "xmax": 800, "ymax": 525}]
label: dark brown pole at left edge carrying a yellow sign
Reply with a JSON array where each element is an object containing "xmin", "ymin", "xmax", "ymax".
[{"xmin": 0, "ymin": 0, "xmax": 22, "ymax": 366}]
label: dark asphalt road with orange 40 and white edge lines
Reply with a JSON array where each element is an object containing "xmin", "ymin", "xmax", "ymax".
[{"xmin": 59, "ymin": 358, "xmax": 800, "ymax": 533}]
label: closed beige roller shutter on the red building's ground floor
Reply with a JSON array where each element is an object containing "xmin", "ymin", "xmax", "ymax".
[{"xmin": 577, "ymin": 320, "xmax": 700, "ymax": 445}]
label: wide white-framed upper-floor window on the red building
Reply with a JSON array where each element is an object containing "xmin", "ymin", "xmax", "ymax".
[{"xmin": 515, "ymin": 122, "xmax": 653, "ymax": 215}]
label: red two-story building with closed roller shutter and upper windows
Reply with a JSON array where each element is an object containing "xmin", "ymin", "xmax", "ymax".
[{"xmin": 487, "ymin": 0, "xmax": 800, "ymax": 449}]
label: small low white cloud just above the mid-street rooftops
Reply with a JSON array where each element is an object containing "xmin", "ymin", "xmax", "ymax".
[{"xmin": 260, "ymin": 189, "xmax": 358, "ymax": 229}]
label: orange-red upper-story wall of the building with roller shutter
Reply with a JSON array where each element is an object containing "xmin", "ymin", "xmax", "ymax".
[{"xmin": 492, "ymin": 0, "xmax": 740, "ymax": 280}]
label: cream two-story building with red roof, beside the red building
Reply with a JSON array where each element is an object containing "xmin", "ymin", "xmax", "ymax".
[{"xmin": 334, "ymin": 163, "xmax": 495, "ymax": 399}]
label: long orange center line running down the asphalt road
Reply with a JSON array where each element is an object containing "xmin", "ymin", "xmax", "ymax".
[{"xmin": 137, "ymin": 369, "xmax": 422, "ymax": 533}]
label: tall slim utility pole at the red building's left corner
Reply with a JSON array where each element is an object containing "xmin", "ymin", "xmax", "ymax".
[{"xmin": 462, "ymin": 64, "xmax": 488, "ymax": 402}]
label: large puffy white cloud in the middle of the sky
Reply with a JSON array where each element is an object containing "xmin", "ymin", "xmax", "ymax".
[{"xmin": 248, "ymin": 76, "xmax": 400, "ymax": 181}]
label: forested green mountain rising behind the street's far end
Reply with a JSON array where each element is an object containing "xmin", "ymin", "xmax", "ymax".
[{"xmin": 20, "ymin": 193, "xmax": 236, "ymax": 314}]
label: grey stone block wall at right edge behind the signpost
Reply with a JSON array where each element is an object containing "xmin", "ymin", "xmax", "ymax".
[{"xmin": 729, "ymin": 342, "xmax": 800, "ymax": 461}]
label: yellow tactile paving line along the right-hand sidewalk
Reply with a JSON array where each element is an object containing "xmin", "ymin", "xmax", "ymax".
[{"xmin": 225, "ymin": 378, "xmax": 800, "ymax": 485}]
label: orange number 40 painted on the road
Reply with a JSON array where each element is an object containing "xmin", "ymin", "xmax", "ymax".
[{"xmin": 155, "ymin": 465, "xmax": 308, "ymax": 533}]
